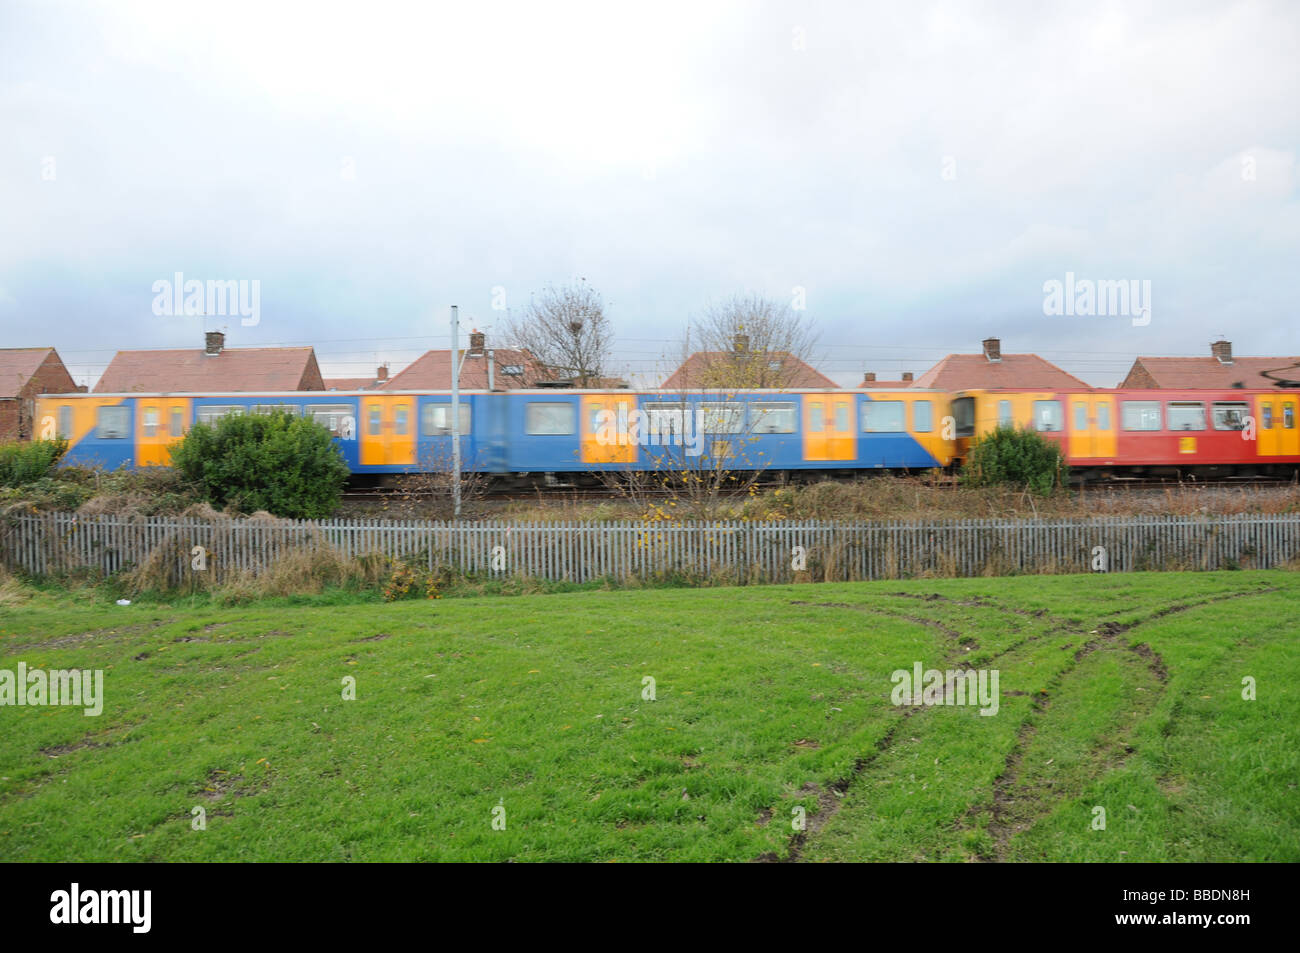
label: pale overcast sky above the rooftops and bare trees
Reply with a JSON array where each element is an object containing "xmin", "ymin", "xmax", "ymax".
[{"xmin": 0, "ymin": 0, "xmax": 1300, "ymax": 386}]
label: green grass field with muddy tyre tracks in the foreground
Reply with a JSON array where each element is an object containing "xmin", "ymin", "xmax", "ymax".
[{"xmin": 0, "ymin": 572, "xmax": 1300, "ymax": 861}]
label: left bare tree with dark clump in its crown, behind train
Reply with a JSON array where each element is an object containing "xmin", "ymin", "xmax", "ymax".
[{"xmin": 506, "ymin": 280, "xmax": 614, "ymax": 387}]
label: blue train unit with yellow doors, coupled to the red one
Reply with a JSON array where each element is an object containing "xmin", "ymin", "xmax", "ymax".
[{"xmin": 38, "ymin": 390, "xmax": 953, "ymax": 475}]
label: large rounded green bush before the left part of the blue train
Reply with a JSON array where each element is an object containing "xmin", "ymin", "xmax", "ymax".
[{"xmin": 172, "ymin": 411, "xmax": 348, "ymax": 519}]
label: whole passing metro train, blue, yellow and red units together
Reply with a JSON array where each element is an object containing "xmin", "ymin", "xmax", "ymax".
[{"xmin": 35, "ymin": 387, "xmax": 1300, "ymax": 485}]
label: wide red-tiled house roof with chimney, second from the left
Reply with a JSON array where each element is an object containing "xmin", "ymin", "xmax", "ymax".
[{"xmin": 95, "ymin": 332, "xmax": 325, "ymax": 394}]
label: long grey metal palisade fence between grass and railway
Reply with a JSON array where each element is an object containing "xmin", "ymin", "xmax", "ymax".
[{"xmin": 0, "ymin": 514, "xmax": 1300, "ymax": 582}]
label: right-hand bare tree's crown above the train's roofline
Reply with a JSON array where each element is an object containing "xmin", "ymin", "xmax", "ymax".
[{"xmin": 680, "ymin": 294, "xmax": 816, "ymax": 390}]
